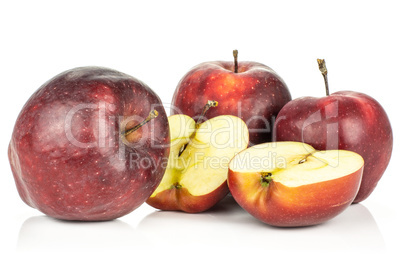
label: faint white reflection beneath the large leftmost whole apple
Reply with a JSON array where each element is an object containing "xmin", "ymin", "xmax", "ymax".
[{"xmin": 17, "ymin": 216, "xmax": 149, "ymax": 253}]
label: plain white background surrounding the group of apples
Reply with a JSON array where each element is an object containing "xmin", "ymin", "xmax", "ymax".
[{"xmin": 0, "ymin": 0, "xmax": 402, "ymax": 267}]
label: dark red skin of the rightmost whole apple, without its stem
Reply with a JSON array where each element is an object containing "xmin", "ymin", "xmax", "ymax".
[{"xmin": 274, "ymin": 91, "xmax": 393, "ymax": 203}]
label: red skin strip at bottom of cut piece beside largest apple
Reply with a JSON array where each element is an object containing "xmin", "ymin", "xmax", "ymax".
[{"xmin": 147, "ymin": 181, "xmax": 229, "ymax": 213}]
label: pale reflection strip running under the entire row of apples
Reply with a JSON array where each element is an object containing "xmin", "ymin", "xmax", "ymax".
[{"xmin": 17, "ymin": 197, "xmax": 385, "ymax": 253}]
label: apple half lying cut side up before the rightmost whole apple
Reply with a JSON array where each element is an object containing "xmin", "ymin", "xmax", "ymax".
[{"xmin": 228, "ymin": 142, "xmax": 364, "ymax": 227}]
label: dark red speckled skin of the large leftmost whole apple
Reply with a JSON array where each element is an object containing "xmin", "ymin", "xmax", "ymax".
[{"xmin": 8, "ymin": 67, "xmax": 170, "ymax": 221}]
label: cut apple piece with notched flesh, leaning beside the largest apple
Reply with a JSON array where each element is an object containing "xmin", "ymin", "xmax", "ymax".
[{"xmin": 147, "ymin": 114, "xmax": 249, "ymax": 213}]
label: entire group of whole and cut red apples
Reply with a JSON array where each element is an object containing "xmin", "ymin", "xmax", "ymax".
[{"xmin": 8, "ymin": 50, "xmax": 393, "ymax": 227}]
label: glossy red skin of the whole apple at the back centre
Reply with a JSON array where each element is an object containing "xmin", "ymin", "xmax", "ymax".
[{"xmin": 171, "ymin": 61, "xmax": 291, "ymax": 146}]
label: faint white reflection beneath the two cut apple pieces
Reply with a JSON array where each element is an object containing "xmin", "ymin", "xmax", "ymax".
[{"xmin": 137, "ymin": 196, "xmax": 385, "ymax": 251}]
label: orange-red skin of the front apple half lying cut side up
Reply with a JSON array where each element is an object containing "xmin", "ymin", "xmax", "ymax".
[{"xmin": 228, "ymin": 167, "xmax": 363, "ymax": 227}]
